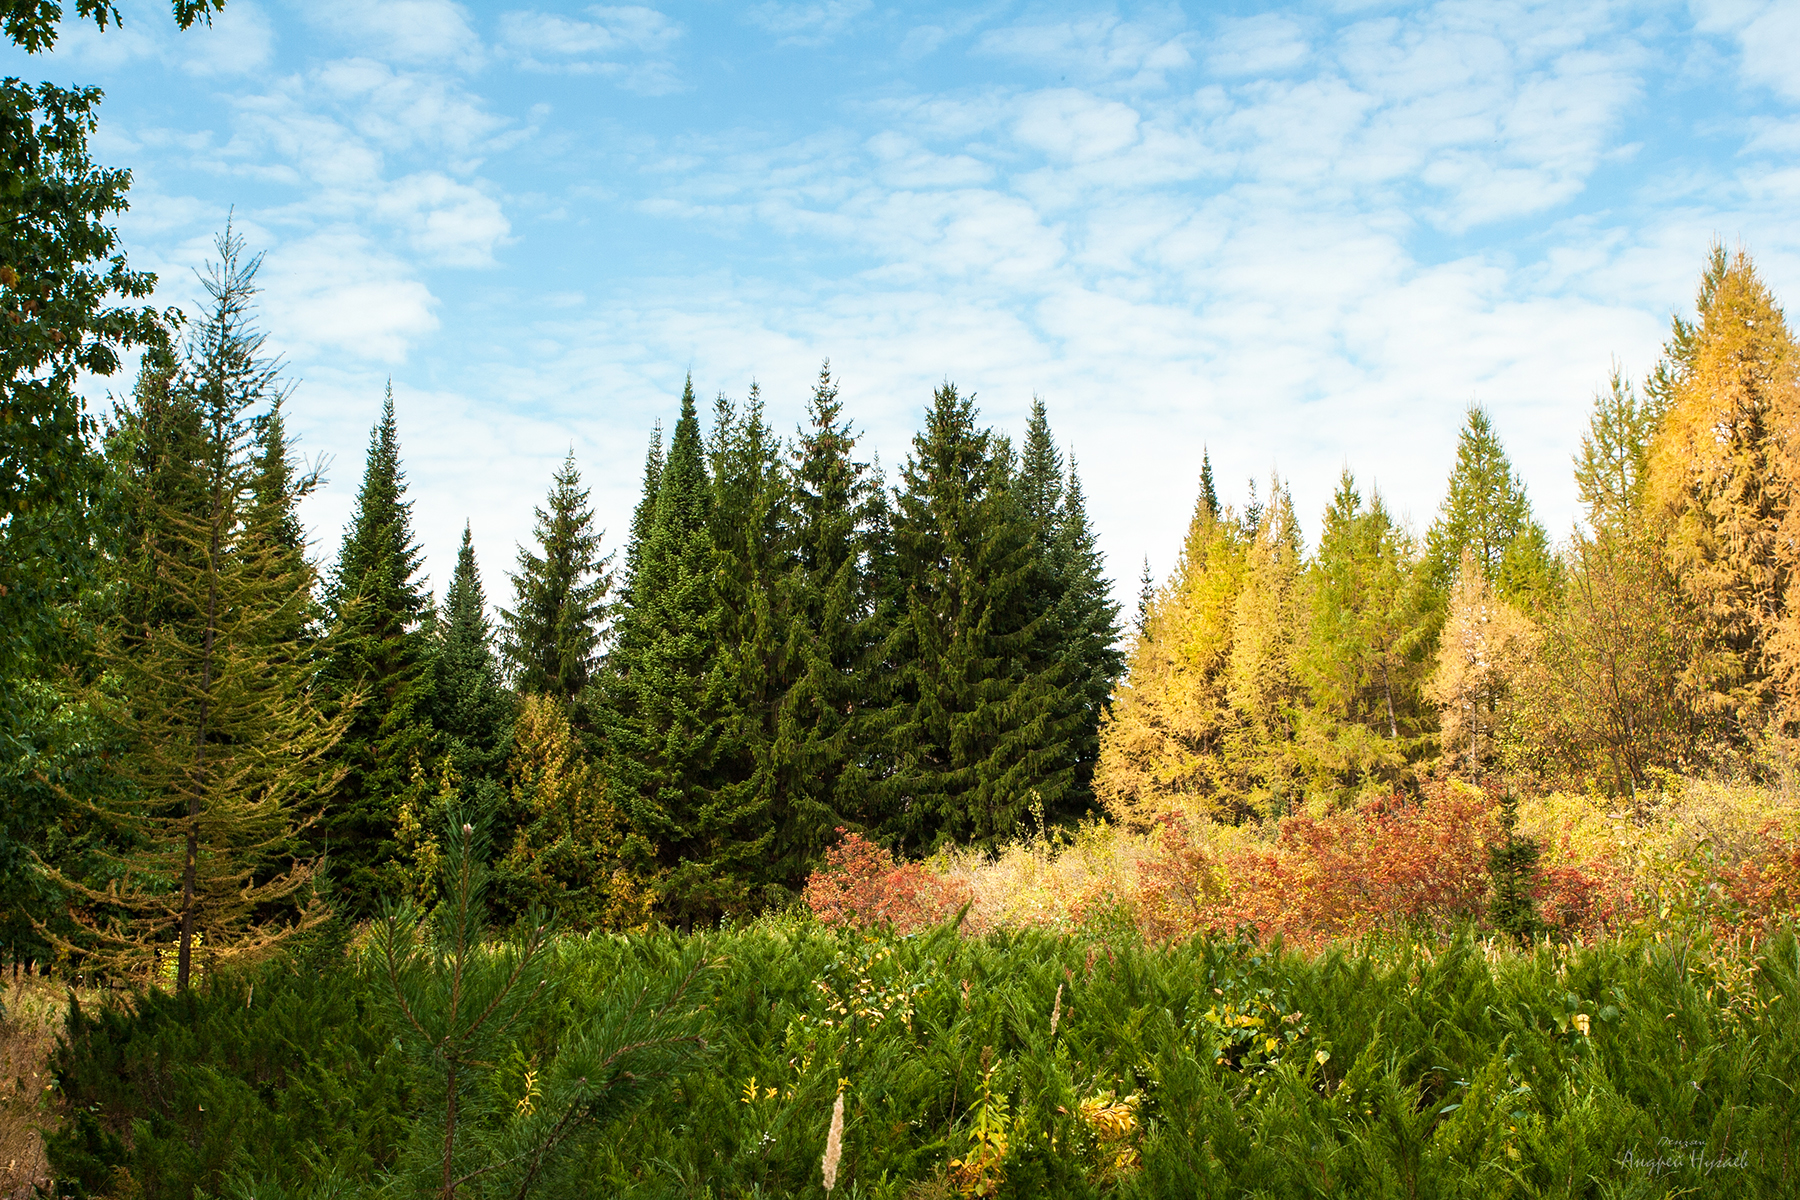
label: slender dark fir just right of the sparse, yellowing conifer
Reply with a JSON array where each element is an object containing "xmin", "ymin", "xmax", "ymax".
[{"xmin": 320, "ymin": 385, "xmax": 434, "ymax": 914}]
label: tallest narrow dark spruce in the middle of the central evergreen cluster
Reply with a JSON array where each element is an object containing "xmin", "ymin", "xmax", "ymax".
[{"xmin": 770, "ymin": 362, "xmax": 891, "ymax": 887}]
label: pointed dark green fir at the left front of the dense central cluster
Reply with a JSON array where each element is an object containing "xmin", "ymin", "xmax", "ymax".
[{"xmin": 603, "ymin": 380, "xmax": 770, "ymax": 927}]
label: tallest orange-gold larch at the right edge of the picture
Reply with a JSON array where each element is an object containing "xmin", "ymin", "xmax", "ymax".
[{"xmin": 1647, "ymin": 245, "xmax": 1800, "ymax": 741}]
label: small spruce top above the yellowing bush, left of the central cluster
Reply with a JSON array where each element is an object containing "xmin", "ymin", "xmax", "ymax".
[{"xmin": 500, "ymin": 450, "xmax": 612, "ymax": 703}]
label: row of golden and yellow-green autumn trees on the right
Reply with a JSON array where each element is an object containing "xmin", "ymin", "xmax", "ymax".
[{"xmin": 1096, "ymin": 246, "xmax": 1800, "ymax": 822}]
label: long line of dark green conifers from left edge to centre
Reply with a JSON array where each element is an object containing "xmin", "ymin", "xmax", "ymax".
[{"xmin": 7, "ymin": 230, "xmax": 1121, "ymax": 984}]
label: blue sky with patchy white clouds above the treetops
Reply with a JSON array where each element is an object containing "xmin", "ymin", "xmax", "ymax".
[{"xmin": 0, "ymin": 0, "xmax": 1800, "ymax": 601}]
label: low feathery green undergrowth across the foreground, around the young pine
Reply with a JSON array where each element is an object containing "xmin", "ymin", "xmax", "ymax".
[{"xmin": 42, "ymin": 918, "xmax": 1800, "ymax": 1200}]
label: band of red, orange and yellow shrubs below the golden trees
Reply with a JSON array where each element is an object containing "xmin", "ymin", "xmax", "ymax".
[{"xmin": 806, "ymin": 781, "xmax": 1800, "ymax": 948}]
